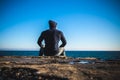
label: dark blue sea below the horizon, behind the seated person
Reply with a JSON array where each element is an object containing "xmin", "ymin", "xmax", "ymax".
[{"xmin": 0, "ymin": 51, "xmax": 120, "ymax": 60}]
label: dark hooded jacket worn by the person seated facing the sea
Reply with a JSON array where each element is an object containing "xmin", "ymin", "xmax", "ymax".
[{"xmin": 38, "ymin": 20, "xmax": 66, "ymax": 56}]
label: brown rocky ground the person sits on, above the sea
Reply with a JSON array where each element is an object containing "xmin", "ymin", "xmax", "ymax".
[{"xmin": 0, "ymin": 56, "xmax": 120, "ymax": 80}]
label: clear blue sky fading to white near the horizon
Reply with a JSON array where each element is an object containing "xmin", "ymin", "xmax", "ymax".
[{"xmin": 0, "ymin": 0, "xmax": 120, "ymax": 50}]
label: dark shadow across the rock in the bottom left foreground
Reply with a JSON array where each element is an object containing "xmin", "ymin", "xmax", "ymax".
[{"xmin": 0, "ymin": 67, "xmax": 68, "ymax": 80}]
